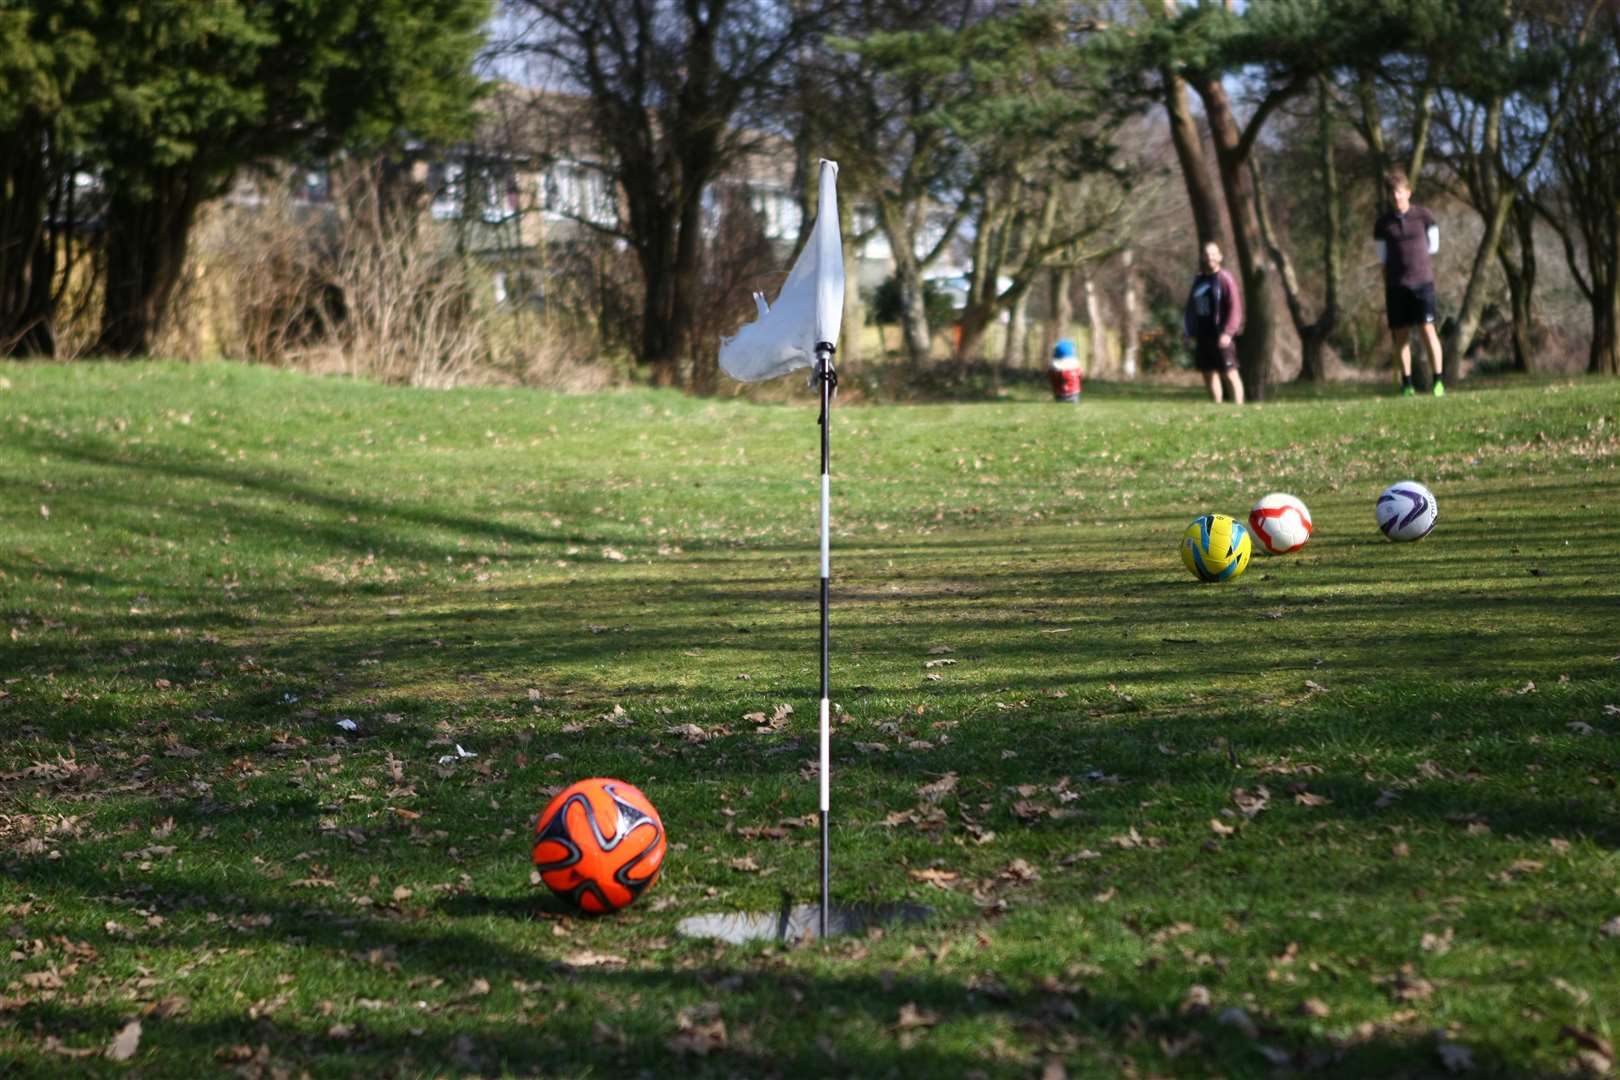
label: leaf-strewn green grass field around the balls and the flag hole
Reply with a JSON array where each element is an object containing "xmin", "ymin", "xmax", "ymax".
[{"xmin": 0, "ymin": 364, "xmax": 1620, "ymax": 1078}]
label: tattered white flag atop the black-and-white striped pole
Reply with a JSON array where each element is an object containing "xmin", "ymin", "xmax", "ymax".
[{"xmin": 719, "ymin": 159, "xmax": 844, "ymax": 382}]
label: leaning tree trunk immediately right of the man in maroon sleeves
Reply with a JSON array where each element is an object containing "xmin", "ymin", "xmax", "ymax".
[{"xmin": 1196, "ymin": 79, "xmax": 1277, "ymax": 402}]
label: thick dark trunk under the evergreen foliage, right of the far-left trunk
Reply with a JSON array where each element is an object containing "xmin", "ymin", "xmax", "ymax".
[{"xmin": 96, "ymin": 165, "xmax": 203, "ymax": 356}]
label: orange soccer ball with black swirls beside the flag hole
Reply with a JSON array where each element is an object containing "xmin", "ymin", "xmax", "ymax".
[{"xmin": 535, "ymin": 777, "xmax": 664, "ymax": 915}]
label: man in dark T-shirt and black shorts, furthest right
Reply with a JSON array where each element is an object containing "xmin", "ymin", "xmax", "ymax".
[{"xmin": 1372, "ymin": 170, "xmax": 1445, "ymax": 397}]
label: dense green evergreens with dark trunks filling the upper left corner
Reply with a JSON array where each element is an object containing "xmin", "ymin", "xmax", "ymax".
[{"xmin": 0, "ymin": 0, "xmax": 489, "ymax": 356}]
